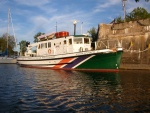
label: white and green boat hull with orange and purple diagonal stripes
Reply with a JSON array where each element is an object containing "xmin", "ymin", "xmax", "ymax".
[{"xmin": 17, "ymin": 50, "xmax": 122, "ymax": 71}]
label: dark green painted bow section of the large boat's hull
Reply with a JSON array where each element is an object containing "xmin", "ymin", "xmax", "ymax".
[{"xmin": 76, "ymin": 51, "xmax": 122, "ymax": 69}]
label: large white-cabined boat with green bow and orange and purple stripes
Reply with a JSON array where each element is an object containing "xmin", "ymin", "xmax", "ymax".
[{"xmin": 17, "ymin": 31, "xmax": 123, "ymax": 72}]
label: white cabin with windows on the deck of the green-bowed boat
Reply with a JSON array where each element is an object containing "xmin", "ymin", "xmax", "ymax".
[{"xmin": 25, "ymin": 31, "xmax": 91, "ymax": 56}]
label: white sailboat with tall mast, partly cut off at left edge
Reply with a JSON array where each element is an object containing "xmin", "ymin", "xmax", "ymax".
[{"xmin": 0, "ymin": 9, "xmax": 17, "ymax": 64}]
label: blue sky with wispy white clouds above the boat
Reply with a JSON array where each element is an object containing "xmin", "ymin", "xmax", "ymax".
[{"xmin": 0, "ymin": 0, "xmax": 150, "ymax": 43}]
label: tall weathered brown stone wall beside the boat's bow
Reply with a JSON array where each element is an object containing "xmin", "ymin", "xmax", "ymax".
[{"xmin": 97, "ymin": 18, "xmax": 150, "ymax": 64}]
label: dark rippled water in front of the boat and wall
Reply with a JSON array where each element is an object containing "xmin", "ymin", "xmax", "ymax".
[{"xmin": 0, "ymin": 64, "xmax": 150, "ymax": 113}]
